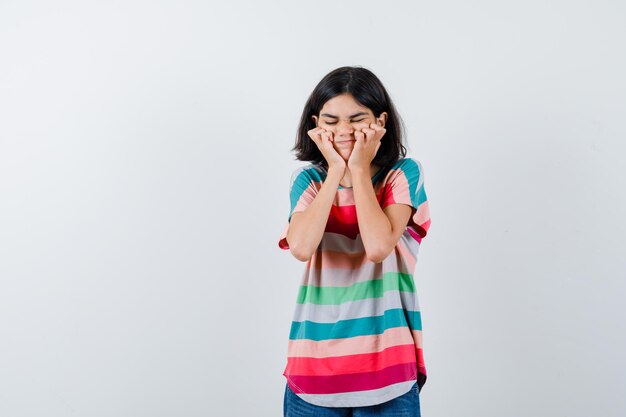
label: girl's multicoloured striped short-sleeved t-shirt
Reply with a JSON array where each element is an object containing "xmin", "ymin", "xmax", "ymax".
[{"xmin": 278, "ymin": 157, "xmax": 430, "ymax": 407}]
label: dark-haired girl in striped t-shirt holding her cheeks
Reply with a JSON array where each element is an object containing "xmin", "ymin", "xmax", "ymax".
[{"xmin": 278, "ymin": 67, "xmax": 430, "ymax": 417}]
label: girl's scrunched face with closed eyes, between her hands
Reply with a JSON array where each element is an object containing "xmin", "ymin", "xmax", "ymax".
[{"xmin": 312, "ymin": 93, "xmax": 387, "ymax": 161}]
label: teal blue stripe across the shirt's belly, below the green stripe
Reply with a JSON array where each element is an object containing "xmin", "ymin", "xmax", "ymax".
[{"xmin": 289, "ymin": 308, "xmax": 422, "ymax": 341}]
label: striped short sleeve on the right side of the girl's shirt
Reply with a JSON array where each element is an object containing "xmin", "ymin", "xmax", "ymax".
[{"xmin": 381, "ymin": 158, "xmax": 430, "ymax": 238}]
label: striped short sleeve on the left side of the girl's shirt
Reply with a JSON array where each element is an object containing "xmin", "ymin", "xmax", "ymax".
[{"xmin": 278, "ymin": 165, "xmax": 322, "ymax": 250}]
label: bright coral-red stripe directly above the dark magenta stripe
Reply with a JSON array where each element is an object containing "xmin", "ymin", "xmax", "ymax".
[{"xmin": 287, "ymin": 344, "xmax": 417, "ymax": 376}]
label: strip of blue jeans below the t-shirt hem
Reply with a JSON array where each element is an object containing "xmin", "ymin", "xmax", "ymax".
[{"xmin": 283, "ymin": 382, "xmax": 420, "ymax": 417}]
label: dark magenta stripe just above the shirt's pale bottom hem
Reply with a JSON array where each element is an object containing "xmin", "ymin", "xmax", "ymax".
[{"xmin": 285, "ymin": 362, "xmax": 417, "ymax": 394}]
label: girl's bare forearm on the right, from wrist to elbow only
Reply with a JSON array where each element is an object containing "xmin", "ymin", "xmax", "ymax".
[{"xmin": 351, "ymin": 167, "xmax": 392, "ymax": 262}]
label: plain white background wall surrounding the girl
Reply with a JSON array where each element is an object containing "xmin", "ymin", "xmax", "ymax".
[{"xmin": 0, "ymin": 0, "xmax": 626, "ymax": 417}]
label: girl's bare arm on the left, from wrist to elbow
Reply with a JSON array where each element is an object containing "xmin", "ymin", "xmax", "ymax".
[{"xmin": 287, "ymin": 168, "xmax": 343, "ymax": 262}]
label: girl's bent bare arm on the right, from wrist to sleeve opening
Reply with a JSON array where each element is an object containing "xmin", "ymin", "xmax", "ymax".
[{"xmin": 352, "ymin": 170, "xmax": 413, "ymax": 263}]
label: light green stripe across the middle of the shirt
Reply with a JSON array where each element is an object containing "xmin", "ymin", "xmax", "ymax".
[{"xmin": 296, "ymin": 272, "xmax": 415, "ymax": 305}]
